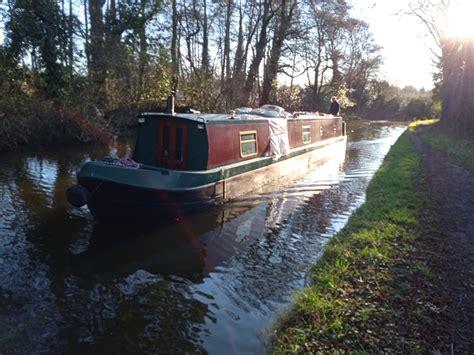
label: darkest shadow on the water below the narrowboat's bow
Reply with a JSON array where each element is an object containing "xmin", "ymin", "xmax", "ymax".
[{"xmin": 72, "ymin": 203, "xmax": 262, "ymax": 282}]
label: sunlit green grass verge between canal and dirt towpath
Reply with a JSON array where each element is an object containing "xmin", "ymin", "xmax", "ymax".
[{"xmin": 273, "ymin": 126, "xmax": 444, "ymax": 353}]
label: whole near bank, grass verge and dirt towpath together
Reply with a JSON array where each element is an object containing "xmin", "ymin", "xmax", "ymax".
[{"xmin": 274, "ymin": 121, "xmax": 474, "ymax": 353}]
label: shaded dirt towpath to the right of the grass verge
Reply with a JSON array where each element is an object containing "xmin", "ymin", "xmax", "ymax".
[{"xmin": 412, "ymin": 135, "xmax": 474, "ymax": 354}]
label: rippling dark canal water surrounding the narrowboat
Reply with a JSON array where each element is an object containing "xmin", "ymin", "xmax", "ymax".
[{"xmin": 0, "ymin": 122, "xmax": 404, "ymax": 354}]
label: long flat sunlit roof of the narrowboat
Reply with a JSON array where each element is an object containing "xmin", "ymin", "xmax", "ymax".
[{"xmin": 139, "ymin": 112, "xmax": 337, "ymax": 123}]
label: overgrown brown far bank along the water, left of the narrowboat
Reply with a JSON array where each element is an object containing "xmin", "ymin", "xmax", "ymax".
[{"xmin": 0, "ymin": 96, "xmax": 198, "ymax": 152}]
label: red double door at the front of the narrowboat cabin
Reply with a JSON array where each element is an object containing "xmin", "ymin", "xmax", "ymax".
[{"xmin": 157, "ymin": 122, "xmax": 188, "ymax": 169}]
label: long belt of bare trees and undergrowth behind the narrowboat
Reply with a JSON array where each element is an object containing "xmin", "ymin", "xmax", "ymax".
[{"xmin": 0, "ymin": 0, "xmax": 436, "ymax": 150}]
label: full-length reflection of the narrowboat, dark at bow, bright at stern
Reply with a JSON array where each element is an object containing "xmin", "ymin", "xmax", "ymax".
[{"xmin": 69, "ymin": 138, "xmax": 345, "ymax": 282}]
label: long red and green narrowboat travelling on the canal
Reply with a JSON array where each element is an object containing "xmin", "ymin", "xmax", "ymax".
[{"xmin": 66, "ymin": 105, "xmax": 346, "ymax": 218}]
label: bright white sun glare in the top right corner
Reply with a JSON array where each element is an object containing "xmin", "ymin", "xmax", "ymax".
[{"xmin": 446, "ymin": 0, "xmax": 474, "ymax": 39}]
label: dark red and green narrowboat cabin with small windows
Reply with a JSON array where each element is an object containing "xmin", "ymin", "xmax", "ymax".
[{"xmin": 133, "ymin": 113, "xmax": 344, "ymax": 171}]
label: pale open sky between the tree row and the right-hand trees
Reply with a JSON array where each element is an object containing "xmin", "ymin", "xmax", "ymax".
[{"xmin": 352, "ymin": 0, "xmax": 436, "ymax": 90}]
